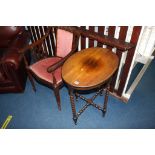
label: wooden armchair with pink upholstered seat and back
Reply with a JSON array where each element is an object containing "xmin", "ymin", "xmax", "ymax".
[{"xmin": 20, "ymin": 27, "xmax": 79, "ymax": 110}]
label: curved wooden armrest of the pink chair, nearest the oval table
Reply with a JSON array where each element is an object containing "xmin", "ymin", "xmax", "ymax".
[{"xmin": 47, "ymin": 36, "xmax": 79, "ymax": 73}]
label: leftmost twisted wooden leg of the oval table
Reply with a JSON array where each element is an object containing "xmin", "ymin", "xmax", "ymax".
[{"xmin": 69, "ymin": 88, "xmax": 77, "ymax": 125}]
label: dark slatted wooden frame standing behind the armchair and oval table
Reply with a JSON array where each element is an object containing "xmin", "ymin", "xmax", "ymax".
[{"xmin": 28, "ymin": 26, "xmax": 139, "ymax": 102}]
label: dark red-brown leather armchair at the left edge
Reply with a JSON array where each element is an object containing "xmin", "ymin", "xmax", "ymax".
[{"xmin": 0, "ymin": 26, "xmax": 30, "ymax": 93}]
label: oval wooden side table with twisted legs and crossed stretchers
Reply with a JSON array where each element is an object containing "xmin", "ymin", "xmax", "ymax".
[{"xmin": 62, "ymin": 47, "xmax": 119, "ymax": 124}]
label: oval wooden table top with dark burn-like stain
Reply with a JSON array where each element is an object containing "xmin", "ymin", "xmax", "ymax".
[{"xmin": 62, "ymin": 47, "xmax": 119, "ymax": 90}]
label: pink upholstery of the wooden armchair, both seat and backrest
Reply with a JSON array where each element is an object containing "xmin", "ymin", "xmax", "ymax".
[{"xmin": 29, "ymin": 29, "xmax": 73, "ymax": 84}]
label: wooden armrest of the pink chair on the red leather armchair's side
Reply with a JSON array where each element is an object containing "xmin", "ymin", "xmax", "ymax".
[{"xmin": 18, "ymin": 27, "xmax": 51, "ymax": 54}]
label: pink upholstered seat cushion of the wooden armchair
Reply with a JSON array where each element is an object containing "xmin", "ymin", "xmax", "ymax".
[{"xmin": 29, "ymin": 57, "xmax": 62, "ymax": 84}]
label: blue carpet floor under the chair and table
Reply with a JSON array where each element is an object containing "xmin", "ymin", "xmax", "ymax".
[{"xmin": 0, "ymin": 61, "xmax": 155, "ymax": 129}]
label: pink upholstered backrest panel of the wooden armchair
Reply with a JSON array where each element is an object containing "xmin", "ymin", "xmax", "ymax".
[{"xmin": 56, "ymin": 29, "xmax": 73, "ymax": 57}]
